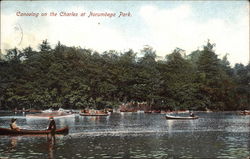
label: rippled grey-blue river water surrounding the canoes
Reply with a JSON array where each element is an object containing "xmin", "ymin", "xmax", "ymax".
[{"xmin": 0, "ymin": 112, "xmax": 250, "ymax": 159}]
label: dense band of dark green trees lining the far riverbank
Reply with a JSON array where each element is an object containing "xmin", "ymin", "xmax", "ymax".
[{"xmin": 0, "ymin": 40, "xmax": 250, "ymax": 110}]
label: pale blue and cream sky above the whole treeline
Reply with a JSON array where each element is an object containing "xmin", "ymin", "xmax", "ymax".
[{"xmin": 0, "ymin": 0, "xmax": 250, "ymax": 65}]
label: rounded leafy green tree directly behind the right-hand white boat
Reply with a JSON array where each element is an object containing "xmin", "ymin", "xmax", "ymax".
[{"xmin": 162, "ymin": 48, "xmax": 200, "ymax": 109}]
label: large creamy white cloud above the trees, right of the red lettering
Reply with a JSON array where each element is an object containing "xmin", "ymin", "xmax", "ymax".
[{"xmin": 140, "ymin": 5, "xmax": 249, "ymax": 64}]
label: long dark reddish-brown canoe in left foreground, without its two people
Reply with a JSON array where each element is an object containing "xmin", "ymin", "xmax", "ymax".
[{"xmin": 0, "ymin": 127, "xmax": 69, "ymax": 135}]
